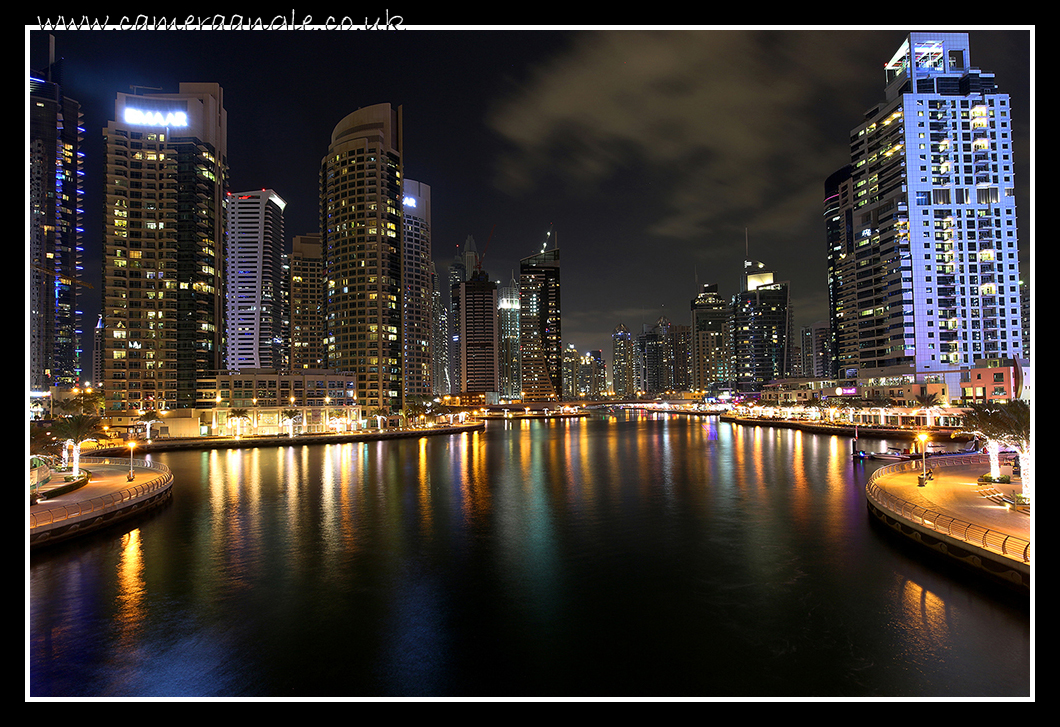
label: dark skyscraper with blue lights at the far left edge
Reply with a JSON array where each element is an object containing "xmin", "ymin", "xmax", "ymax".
[{"xmin": 29, "ymin": 49, "xmax": 84, "ymax": 391}]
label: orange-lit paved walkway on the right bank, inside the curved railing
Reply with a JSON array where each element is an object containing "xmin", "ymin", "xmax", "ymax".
[{"xmin": 877, "ymin": 457, "xmax": 1030, "ymax": 540}]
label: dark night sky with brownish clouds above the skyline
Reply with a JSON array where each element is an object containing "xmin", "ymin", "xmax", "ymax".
[{"xmin": 27, "ymin": 24, "xmax": 1034, "ymax": 370}]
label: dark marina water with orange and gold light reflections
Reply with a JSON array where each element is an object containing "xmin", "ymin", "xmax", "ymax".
[{"xmin": 28, "ymin": 413, "xmax": 1032, "ymax": 697}]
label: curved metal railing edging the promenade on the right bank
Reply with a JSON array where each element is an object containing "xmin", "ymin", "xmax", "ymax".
[{"xmin": 865, "ymin": 455, "xmax": 1030, "ymax": 564}]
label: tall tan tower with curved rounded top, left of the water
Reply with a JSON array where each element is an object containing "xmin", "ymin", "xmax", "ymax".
[{"xmin": 320, "ymin": 104, "xmax": 404, "ymax": 411}]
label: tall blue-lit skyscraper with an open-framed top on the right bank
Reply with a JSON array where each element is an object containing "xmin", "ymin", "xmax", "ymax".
[{"xmin": 832, "ymin": 33, "xmax": 1023, "ymax": 391}]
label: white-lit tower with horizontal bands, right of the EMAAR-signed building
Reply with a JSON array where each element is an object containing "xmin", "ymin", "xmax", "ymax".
[{"xmin": 225, "ymin": 190, "xmax": 287, "ymax": 371}]
